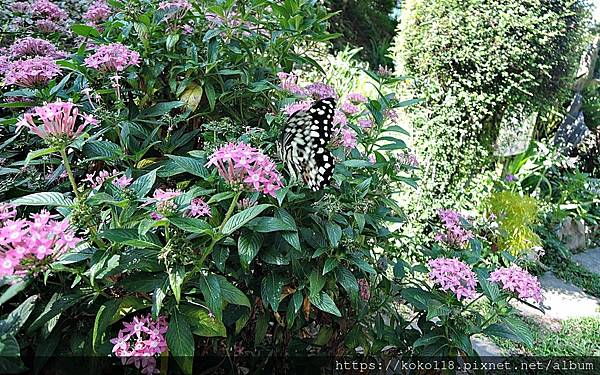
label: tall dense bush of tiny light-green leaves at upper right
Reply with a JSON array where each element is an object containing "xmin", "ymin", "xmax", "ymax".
[{"xmin": 394, "ymin": 0, "xmax": 587, "ymax": 239}]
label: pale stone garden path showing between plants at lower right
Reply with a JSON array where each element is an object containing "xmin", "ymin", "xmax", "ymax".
[{"xmin": 471, "ymin": 248, "xmax": 600, "ymax": 356}]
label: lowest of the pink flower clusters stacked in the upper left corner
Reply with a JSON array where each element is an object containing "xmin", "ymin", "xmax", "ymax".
[{"xmin": 4, "ymin": 56, "xmax": 60, "ymax": 87}]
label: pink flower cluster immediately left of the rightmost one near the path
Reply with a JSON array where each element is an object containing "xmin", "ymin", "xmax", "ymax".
[{"xmin": 428, "ymin": 258, "xmax": 477, "ymax": 301}]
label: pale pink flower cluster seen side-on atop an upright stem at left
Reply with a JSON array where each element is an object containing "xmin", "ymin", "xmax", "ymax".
[{"xmin": 17, "ymin": 100, "xmax": 98, "ymax": 143}]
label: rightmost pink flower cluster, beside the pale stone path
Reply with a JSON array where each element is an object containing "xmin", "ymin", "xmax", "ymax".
[{"xmin": 489, "ymin": 265, "xmax": 542, "ymax": 303}]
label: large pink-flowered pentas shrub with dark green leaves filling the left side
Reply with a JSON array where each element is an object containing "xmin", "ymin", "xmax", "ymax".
[{"xmin": 0, "ymin": 0, "xmax": 540, "ymax": 374}]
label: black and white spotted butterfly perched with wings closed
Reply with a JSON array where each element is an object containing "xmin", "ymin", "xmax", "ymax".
[{"xmin": 277, "ymin": 98, "xmax": 335, "ymax": 191}]
